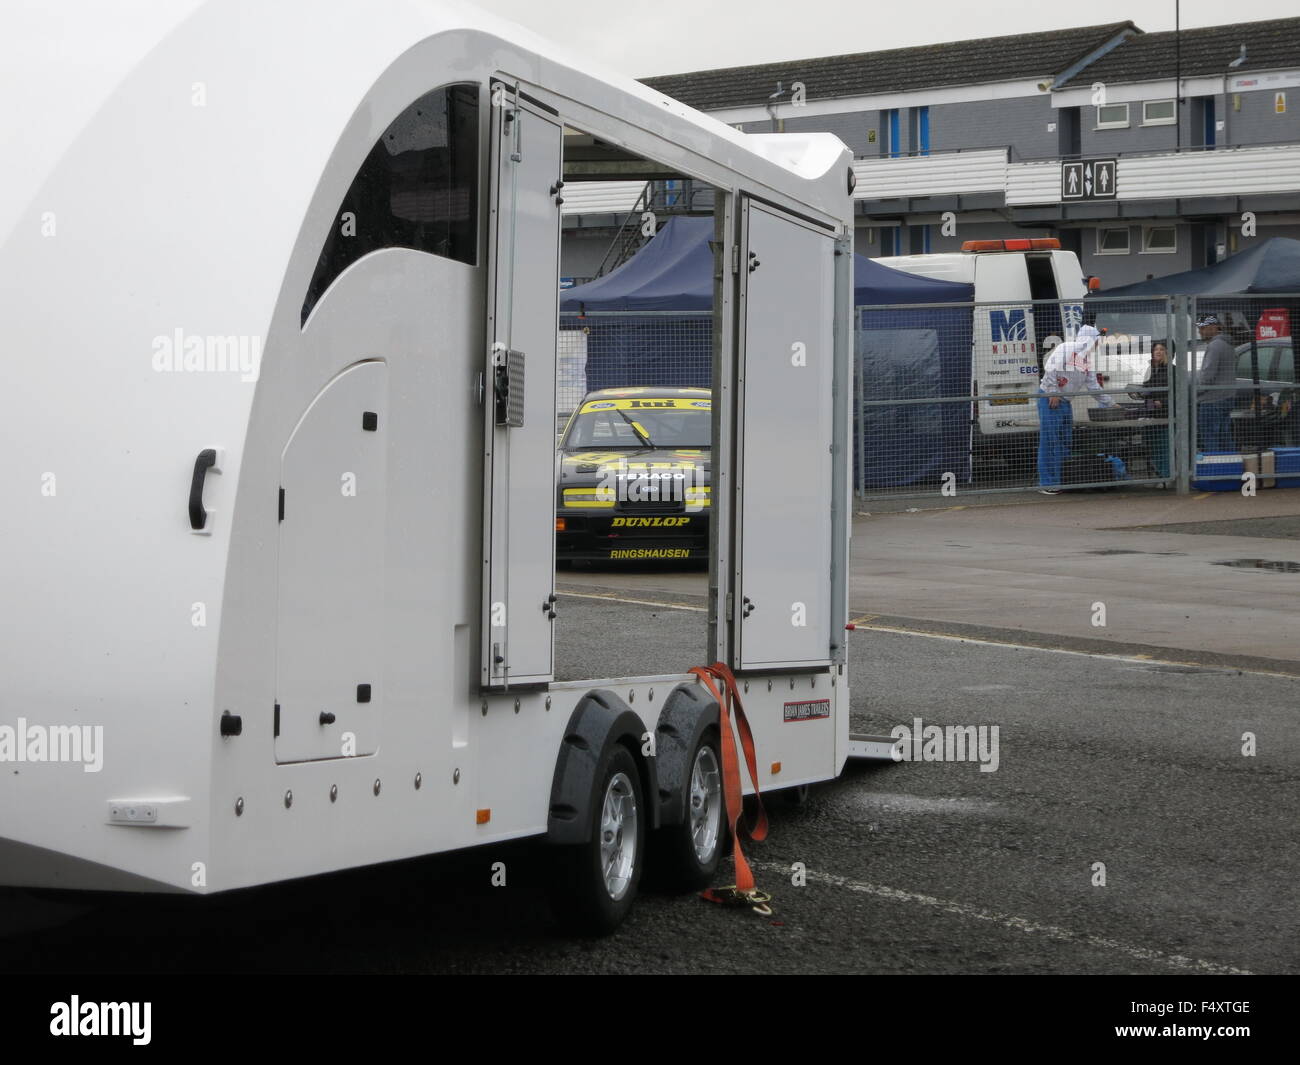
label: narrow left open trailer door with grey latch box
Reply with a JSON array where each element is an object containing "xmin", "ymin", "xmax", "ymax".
[{"xmin": 481, "ymin": 82, "xmax": 563, "ymax": 688}]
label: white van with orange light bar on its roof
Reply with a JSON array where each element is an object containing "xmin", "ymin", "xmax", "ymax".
[{"xmin": 876, "ymin": 238, "xmax": 1096, "ymax": 453}]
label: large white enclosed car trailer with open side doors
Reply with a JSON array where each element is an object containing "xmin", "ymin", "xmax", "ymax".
[{"xmin": 0, "ymin": 0, "xmax": 888, "ymax": 928}]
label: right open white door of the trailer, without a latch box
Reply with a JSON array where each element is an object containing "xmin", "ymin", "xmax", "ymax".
[{"xmin": 732, "ymin": 199, "xmax": 839, "ymax": 670}]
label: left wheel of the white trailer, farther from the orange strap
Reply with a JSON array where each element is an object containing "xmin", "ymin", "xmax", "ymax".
[{"xmin": 551, "ymin": 744, "xmax": 649, "ymax": 935}]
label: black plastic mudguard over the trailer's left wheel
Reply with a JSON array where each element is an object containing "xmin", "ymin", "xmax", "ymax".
[{"xmin": 546, "ymin": 689, "xmax": 659, "ymax": 844}]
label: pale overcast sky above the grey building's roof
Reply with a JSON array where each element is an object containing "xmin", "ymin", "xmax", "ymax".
[{"xmin": 476, "ymin": 0, "xmax": 1297, "ymax": 78}]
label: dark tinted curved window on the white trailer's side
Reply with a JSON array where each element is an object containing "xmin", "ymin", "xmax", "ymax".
[{"xmin": 302, "ymin": 85, "xmax": 478, "ymax": 324}]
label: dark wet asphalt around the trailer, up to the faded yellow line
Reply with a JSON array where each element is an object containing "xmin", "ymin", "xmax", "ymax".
[{"xmin": 0, "ymin": 596, "xmax": 1300, "ymax": 975}]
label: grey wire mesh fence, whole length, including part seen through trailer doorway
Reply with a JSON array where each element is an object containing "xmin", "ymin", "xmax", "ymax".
[{"xmin": 558, "ymin": 295, "xmax": 1300, "ymax": 499}]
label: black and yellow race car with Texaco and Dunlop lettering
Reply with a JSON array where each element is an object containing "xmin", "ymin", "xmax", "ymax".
[{"xmin": 555, "ymin": 388, "xmax": 712, "ymax": 562}]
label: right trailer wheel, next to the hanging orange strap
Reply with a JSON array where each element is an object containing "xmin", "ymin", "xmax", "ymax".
[{"xmin": 651, "ymin": 726, "xmax": 727, "ymax": 891}]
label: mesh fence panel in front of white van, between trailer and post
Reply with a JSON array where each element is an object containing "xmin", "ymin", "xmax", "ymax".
[{"xmin": 854, "ymin": 299, "xmax": 1174, "ymax": 497}]
